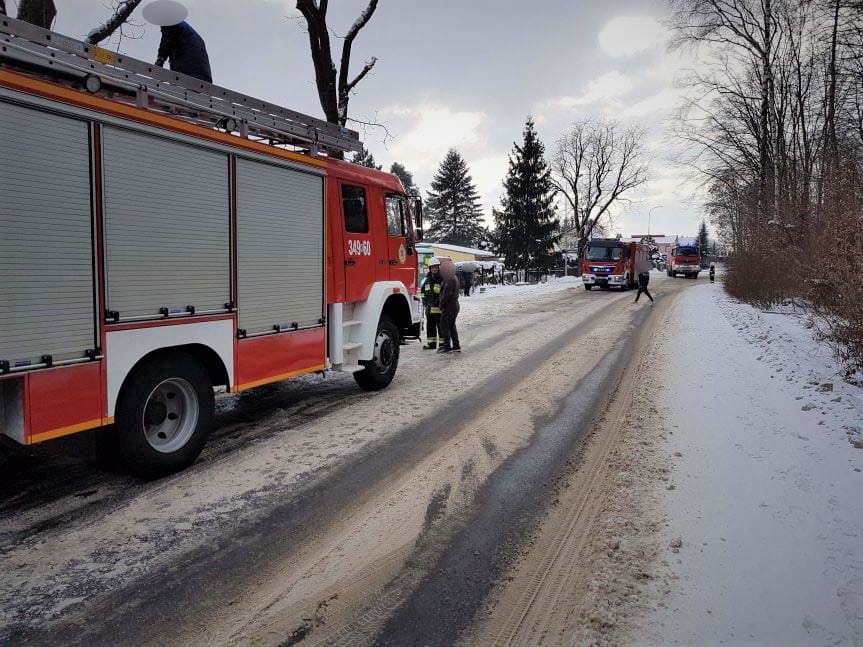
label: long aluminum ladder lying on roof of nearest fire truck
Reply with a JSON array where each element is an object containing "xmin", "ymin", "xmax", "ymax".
[{"xmin": 0, "ymin": 16, "xmax": 362, "ymax": 152}]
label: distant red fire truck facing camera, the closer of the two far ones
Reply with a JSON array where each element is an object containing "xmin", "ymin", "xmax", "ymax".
[{"xmin": 581, "ymin": 238, "xmax": 652, "ymax": 290}]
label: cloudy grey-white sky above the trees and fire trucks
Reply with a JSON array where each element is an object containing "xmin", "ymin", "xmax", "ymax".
[{"xmin": 18, "ymin": 0, "xmax": 702, "ymax": 235}]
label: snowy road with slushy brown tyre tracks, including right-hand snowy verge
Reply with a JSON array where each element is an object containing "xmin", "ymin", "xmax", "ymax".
[{"xmin": 5, "ymin": 273, "xmax": 863, "ymax": 646}]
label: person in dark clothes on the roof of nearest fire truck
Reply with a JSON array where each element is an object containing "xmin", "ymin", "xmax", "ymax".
[{"xmin": 143, "ymin": 0, "xmax": 213, "ymax": 83}]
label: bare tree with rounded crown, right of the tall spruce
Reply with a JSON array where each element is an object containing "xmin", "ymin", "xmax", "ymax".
[{"xmin": 551, "ymin": 119, "xmax": 647, "ymax": 268}]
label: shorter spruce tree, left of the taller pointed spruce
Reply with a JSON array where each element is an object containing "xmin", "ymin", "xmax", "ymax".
[{"xmin": 426, "ymin": 148, "xmax": 486, "ymax": 246}]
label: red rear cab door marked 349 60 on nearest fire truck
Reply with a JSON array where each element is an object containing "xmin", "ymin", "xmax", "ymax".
[{"xmin": 340, "ymin": 182, "xmax": 376, "ymax": 303}]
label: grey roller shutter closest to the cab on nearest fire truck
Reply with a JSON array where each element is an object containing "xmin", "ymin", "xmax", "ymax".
[{"xmin": 237, "ymin": 159, "xmax": 324, "ymax": 335}]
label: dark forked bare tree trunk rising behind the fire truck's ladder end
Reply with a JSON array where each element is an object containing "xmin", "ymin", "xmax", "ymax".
[{"xmin": 297, "ymin": 0, "xmax": 378, "ymax": 132}]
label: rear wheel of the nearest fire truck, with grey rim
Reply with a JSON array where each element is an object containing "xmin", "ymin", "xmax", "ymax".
[{"xmin": 115, "ymin": 353, "xmax": 215, "ymax": 478}]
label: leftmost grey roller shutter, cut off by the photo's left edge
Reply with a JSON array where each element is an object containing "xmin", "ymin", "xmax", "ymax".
[{"xmin": 0, "ymin": 102, "xmax": 96, "ymax": 366}]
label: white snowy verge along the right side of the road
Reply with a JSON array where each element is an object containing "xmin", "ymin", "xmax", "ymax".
[{"xmin": 640, "ymin": 284, "xmax": 863, "ymax": 645}]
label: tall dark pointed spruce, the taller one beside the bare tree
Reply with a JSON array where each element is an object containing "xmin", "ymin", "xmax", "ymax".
[{"xmin": 494, "ymin": 117, "xmax": 560, "ymax": 270}]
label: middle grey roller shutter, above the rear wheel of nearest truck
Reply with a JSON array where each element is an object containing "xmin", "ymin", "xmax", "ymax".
[{"xmin": 103, "ymin": 128, "xmax": 230, "ymax": 321}]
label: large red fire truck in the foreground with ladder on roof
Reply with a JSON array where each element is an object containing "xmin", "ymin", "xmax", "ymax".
[{"xmin": 0, "ymin": 17, "xmax": 422, "ymax": 477}]
